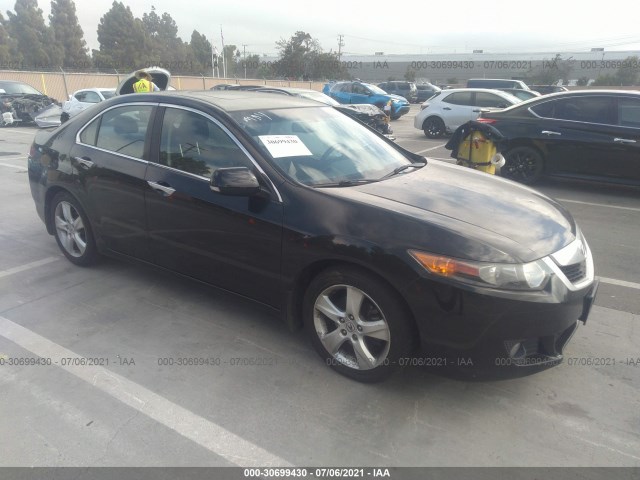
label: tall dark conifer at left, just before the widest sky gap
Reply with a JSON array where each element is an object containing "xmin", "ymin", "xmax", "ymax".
[{"xmin": 49, "ymin": 0, "xmax": 91, "ymax": 69}]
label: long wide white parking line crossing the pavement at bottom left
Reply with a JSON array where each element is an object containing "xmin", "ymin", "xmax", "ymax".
[{"xmin": 0, "ymin": 317, "xmax": 293, "ymax": 467}]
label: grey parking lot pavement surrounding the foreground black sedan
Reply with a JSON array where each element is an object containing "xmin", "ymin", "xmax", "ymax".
[{"xmin": 0, "ymin": 106, "xmax": 640, "ymax": 467}]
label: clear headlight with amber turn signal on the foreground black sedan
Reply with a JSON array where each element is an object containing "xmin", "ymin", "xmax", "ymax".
[{"xmin": 409, "ymin": 250, "xmax": 552, "ymax": 290}]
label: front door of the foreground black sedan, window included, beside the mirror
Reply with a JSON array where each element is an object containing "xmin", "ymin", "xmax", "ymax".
[{"xmin": 146, "ymin": 106, "xmax": 282, "ymax": 306}]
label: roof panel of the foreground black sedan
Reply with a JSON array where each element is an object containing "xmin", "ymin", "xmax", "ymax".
[{"xmin": 110, "ymin": 90, "xmax": 323, "ymax": 112}]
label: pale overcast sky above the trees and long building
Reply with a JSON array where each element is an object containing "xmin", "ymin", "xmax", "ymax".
[{"xmin": 0, "ymin": 0, "xmax": 640, "ymax": 55}]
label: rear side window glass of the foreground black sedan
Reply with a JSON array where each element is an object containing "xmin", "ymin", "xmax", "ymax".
[{"xmin": 80, "ymin": 105, "xmax": 153, "ymax": 158}]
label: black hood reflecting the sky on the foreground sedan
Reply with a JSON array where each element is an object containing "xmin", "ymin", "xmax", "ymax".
[{"xmin": 330, "ymin": 160, "xmax": 576, "ymax": 262}]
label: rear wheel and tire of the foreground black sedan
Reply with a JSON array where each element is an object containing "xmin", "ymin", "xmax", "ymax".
[{"xmin": 50, "ymin": 192, "xmax": 98, "ymax": 267}]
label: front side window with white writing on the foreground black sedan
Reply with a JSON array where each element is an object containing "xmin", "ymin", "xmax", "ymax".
[{"xmin": 159, "ymin": 108, "xmax": 251, "ymax": 178}]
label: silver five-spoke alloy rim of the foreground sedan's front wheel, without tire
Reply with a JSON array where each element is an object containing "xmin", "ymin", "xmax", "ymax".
[{"xmin": 313, "ymin": 285, "xmax": 391, "ymax": 370}]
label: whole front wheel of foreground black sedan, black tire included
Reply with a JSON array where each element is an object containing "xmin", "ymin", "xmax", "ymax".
[{"xmin": 303, "ymin": 267, "xmax": 415, "ymax": 383}]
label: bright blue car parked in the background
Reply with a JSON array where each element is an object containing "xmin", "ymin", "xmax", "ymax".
[{"xmin": 322, "ymin": 81, "xmax": 410, "ymax": 120}]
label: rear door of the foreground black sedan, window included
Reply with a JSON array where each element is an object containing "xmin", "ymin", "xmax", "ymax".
[{"xmin": 71, "ymin": 103, "xmax": 156, "ymax": 260}]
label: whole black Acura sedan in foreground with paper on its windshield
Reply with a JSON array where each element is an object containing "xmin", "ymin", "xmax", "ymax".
[{"xmin": 28, "ymin": 91, "xmax": 597, "ymax": 381}]
